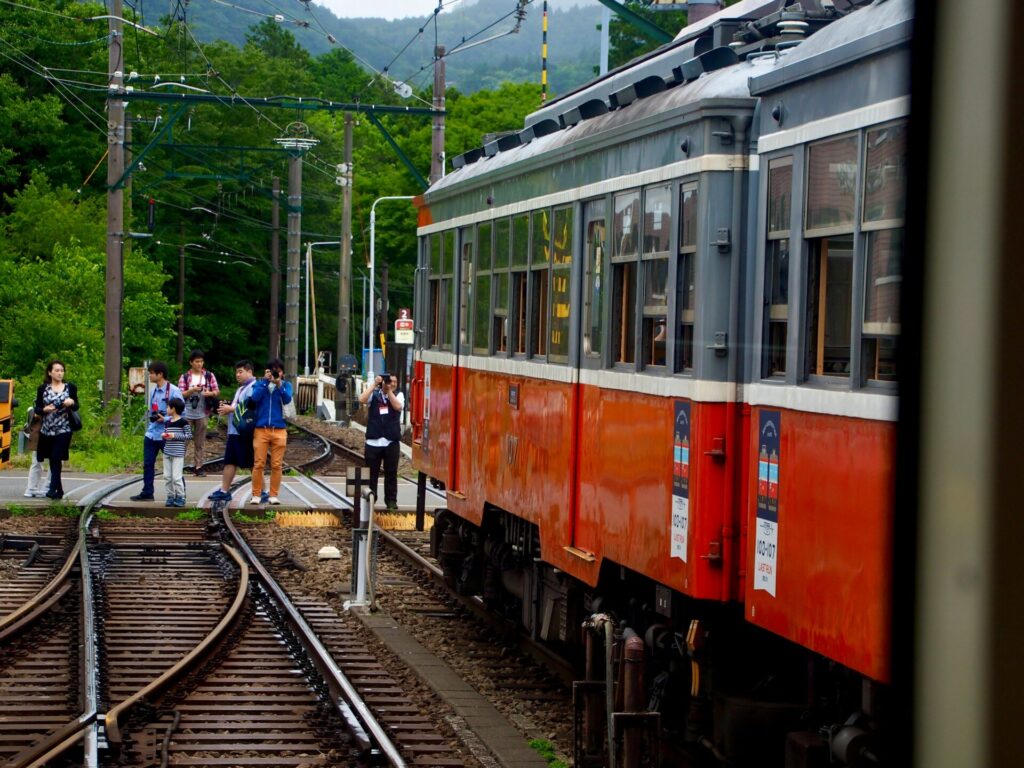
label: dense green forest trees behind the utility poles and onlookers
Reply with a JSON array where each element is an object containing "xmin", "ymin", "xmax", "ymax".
[{"xmin": 0, "ymin": 0, "xmax": 539, "ymax": 415}]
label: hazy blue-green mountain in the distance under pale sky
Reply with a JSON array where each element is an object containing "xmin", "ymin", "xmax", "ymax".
[{"xmin": 179, "ymin": 0, "xmax": 602, "ymax": 99}]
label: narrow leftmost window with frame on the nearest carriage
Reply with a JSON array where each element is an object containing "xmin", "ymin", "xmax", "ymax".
[{"xmin": 761, "ymin": 154, "xmax": 797, "ymax": 380}]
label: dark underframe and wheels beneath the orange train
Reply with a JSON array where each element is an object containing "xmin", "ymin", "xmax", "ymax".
[{"xmin": 431, "ymin": 505, "xmax": 887, "ymax": 768}]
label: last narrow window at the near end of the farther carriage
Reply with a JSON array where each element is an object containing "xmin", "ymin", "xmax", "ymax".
[{"xmin": 672, "ymin": 176, "xmax": 700, "ymax": 376}]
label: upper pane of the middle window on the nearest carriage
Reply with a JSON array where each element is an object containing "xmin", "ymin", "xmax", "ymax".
[{"xmin": 806, "ymin": 135, "xmax": 857, "ymax": 229}]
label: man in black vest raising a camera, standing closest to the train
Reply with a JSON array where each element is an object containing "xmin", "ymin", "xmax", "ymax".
[{"xmin": 359, "ymin": 374, "xmax": 406, "ymax": 512}]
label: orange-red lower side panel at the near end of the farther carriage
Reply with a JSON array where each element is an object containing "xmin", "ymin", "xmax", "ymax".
[{"xmin": 575, "ymin": 386, "xmax": 739, "ymax": 600}]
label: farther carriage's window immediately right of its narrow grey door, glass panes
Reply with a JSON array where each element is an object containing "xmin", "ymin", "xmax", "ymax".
[{"xmin": 611, "ymin": 191, "xmax": 640, "ymax": 364}]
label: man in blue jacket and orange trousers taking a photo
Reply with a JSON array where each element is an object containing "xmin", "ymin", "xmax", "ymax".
[{"xmin": 249, "ymin": 357, "xmax": 292, "ymax": 504}]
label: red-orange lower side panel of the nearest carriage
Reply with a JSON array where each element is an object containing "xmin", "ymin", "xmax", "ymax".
[{"xmin": 745, "ymin": 409, "xmax": 896, "ymax": 682}]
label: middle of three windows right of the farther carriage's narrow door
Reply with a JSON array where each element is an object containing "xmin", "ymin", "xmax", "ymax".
[{"xmin": 638, "ymin": 181, "xmax": 676, "ymax": 373}]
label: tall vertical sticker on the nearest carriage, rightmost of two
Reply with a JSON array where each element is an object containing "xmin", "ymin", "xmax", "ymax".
[{"xmin": 754, "ymin": 411, "xmax": 782, "ymax": 597}]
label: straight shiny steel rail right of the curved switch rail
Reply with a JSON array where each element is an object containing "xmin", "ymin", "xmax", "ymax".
[{"xmin": 221, "ymin": 508, "xmax": 407, "ymax": 768}]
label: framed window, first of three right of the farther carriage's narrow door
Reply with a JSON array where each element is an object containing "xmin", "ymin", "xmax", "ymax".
[{"xmin": 608, "ymin": 187, "xmax": 643, "ymax": 371}]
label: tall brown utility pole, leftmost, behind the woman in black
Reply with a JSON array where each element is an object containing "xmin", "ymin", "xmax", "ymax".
[{"xmin": 103, "ymin": 0, "xmax": 125, "ymax": 437}]
